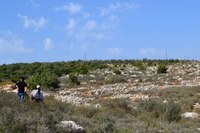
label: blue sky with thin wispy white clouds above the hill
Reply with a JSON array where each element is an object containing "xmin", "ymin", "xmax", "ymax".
[{"xmin": 0, "ymin": 0, "xmax": 200, "ymax": 64}]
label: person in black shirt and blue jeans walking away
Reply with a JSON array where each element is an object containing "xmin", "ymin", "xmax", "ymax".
[{"xmin": 16, "ymin": 77, "xmax": 27, "ymax": 102}]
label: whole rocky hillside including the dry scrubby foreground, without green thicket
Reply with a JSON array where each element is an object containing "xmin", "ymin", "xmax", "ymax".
[{"xmin": 0, "ymin": 61, "xmax": 200, "ymax": 133}]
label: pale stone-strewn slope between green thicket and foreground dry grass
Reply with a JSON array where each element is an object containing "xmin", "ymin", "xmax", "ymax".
[{"xmin": 55, "ymin": 61, "xmax": 200, "ymax": 107}]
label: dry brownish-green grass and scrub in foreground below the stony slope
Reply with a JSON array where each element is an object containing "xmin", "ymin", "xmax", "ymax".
[{"xmin": 0, "ymin": 87, "xmax": 200, "ymax": 133}]
